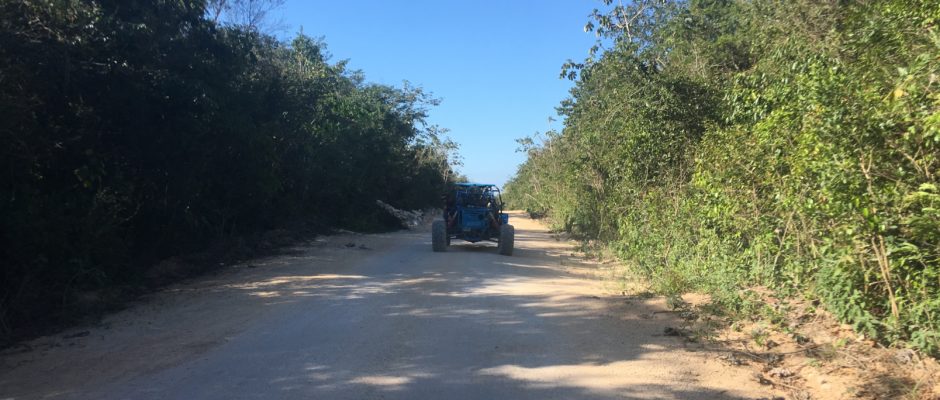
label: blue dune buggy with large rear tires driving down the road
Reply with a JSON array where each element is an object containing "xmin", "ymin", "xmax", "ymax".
[{"xmin": 431, "ymin": 183, "xmax": 515, "ymax": 256}]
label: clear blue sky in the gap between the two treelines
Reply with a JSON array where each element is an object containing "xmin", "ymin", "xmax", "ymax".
[{"xmin": 280, "ymin": 0, "xmax": 602, "ymax": 185}]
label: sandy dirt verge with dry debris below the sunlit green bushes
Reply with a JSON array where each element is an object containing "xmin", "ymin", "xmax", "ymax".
[{"xmin": 677, "ymin": 289, "xmax": 940, "ymax": 400}]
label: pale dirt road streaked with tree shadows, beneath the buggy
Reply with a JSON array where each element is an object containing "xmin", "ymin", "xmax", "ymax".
[{"xmin": 0, "ymin": 214, "xmax": 771, "ymax": 400}]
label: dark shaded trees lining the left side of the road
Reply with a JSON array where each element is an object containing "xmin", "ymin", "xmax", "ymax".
[{"xmin": 0, "ymin": 0, "xmax": 456, "ymax": 337}]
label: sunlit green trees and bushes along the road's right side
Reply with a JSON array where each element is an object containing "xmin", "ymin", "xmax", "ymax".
[{"xmin": 507, "ymin": 0, "xmax": 940, "ymax": 354}]
